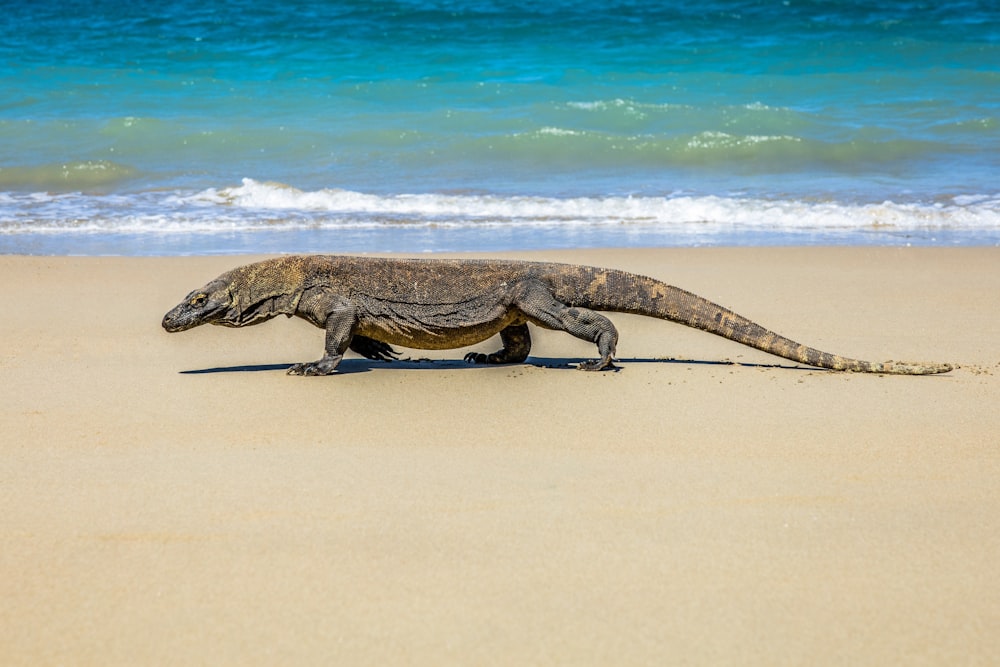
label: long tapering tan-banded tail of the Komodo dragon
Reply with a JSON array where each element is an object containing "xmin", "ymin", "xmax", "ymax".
[{"xmin": 578, "ymin": 269, "xmax": 954, "ymax": 375}]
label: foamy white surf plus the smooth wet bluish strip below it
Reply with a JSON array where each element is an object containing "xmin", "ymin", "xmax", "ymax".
[{"xmin": 0, "ymin": 183, "xmax": 1000, "ymax": 256}]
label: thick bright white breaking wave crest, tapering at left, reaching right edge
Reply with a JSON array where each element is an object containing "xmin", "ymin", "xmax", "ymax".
[{"xmin": 180, "ymin": 179, "xmax": 1000, "ymax": 229}]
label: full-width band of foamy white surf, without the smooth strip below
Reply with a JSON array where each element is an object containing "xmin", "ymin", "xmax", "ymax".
[{"xmin": 0, "ymin": 179, "xmax": 1000, "ymax": 243}]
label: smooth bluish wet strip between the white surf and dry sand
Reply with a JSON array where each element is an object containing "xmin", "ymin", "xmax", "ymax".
[{"xmin": 0, "ymin": 224, "xmax": 1000, "ymax": 258}]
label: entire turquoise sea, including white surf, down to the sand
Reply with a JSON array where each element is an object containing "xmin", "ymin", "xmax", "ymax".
[{"xmin": 0, "ymin": 0, "xmax": 1000, "ymax": 255}]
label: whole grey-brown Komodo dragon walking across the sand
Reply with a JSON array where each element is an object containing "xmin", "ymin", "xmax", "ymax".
[{"xmin": 163, "ymin": 256, "xmax": 953, "ymax": 375}]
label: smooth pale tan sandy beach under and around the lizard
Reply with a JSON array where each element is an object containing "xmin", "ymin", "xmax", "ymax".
[{"xmin": 0, "ymin": 247, "xmax": 1000, "ymax": 666}]
